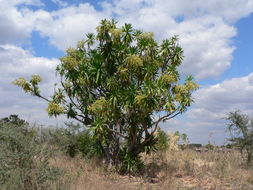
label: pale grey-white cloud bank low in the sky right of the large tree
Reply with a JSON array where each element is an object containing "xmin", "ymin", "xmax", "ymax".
[{"xmin": 163, "ymin": 73, "xmax": 253, "ymax": 144}]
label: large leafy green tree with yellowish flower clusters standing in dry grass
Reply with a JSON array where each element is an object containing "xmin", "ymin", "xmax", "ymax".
[{"xmin": 14, "ymin": 20, "xmax": 198, "ymax": 172}]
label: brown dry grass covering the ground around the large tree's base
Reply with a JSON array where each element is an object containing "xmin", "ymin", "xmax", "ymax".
[{"xmin": 47, "ymin": 150, "xmax": 253, "ymax": 190}]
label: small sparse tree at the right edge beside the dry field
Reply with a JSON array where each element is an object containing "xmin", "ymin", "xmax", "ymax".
[{"xmin": 226, "ymin": 110, "xmax": 253, "ymax": 164}]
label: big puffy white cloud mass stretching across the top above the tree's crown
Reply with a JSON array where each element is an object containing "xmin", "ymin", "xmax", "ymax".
[{"xmin": 0, "ymin": 0, "xmax": 253, "ymax": 80}]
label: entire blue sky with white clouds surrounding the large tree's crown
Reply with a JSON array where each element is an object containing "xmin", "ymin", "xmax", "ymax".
[{"xmin": 0, "ymin": 0, "xmax": 253, "ymax": 145}]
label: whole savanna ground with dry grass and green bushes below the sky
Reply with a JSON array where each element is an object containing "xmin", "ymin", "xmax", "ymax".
[{"xmin": 0, "ymin": 115, "xmax": 253, "ymax": 190}]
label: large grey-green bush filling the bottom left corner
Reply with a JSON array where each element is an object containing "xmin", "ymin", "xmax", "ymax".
[{"xmin": 0, "ymin": 115, "xmax": 60, "ymax": 190}]
